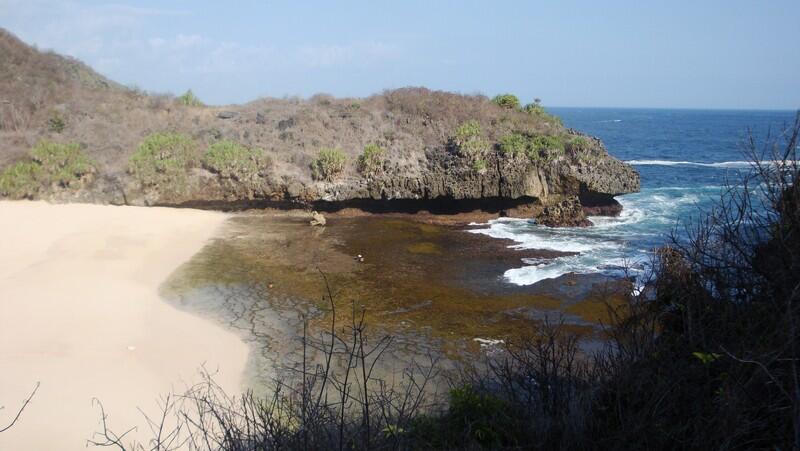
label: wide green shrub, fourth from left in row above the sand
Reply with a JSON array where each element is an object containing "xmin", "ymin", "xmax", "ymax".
[{"xmin": 203, "ymin": 140, "xmax": 270, "ymax": 181}]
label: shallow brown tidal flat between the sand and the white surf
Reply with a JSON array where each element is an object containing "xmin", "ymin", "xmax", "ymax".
[{"xmin": 163, "ymin": 211, "xmax": 616, "ymax": 390}]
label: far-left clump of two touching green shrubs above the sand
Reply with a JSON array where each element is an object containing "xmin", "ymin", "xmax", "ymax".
[{"xmin": 0, "ymin": 140, "xmax": 95, "ymax": 199}]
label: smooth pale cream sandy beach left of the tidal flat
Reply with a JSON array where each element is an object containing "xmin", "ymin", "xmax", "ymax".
[{"xmin": 0, "ymin": 202, "xmax": 248, "ymax": 451}]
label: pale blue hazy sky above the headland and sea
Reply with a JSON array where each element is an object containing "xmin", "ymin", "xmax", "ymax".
[{"xmin": 0, "ymin": 0, "xmax": 800, "ymax": 109}]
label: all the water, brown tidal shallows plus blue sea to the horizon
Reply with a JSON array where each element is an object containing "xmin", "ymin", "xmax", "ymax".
[{"xmin": 164, "ymin": 110, "xmax": 791, "ymax": 386}]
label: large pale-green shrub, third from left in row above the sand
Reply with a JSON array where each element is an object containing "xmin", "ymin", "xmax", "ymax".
[{"xmin": 129, "ymin": 133, "xmax": 200, "ymax": 186}]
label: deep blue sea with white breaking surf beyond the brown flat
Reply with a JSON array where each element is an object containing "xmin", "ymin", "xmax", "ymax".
[{"xmin": 468, "ymin": 108, "xmax": 794, "ymax": 285}]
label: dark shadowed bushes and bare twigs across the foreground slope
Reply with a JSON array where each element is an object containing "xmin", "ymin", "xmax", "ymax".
[{"xmin": 84, "ymin": 115, "xmax": 800, "ymax": 450}]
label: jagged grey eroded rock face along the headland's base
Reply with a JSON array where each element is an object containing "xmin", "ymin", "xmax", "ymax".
[{"xmin": 138, "ymin": 133, "xmax": 639, "ymax": 227}]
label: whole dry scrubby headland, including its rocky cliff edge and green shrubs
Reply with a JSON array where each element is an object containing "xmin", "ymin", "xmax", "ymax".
[{"xmin": 0, "ymin": 31, "xmax": 639, "ymax": 225}]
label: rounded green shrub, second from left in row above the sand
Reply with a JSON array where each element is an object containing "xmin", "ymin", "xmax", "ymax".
[{"xmin": 31, "ymin": 140, "xmax": 94, "ymax": 186}]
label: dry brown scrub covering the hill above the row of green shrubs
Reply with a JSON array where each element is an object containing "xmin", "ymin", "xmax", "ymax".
[{"xmin": 0, "ymin": 30, "xmax": 564, "ymax": 189}]
